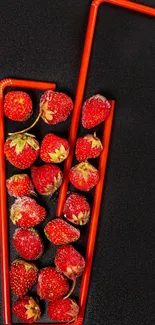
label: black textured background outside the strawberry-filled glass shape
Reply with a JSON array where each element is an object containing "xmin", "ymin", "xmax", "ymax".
[{"xmin": 0, "ymin": 0, "xmax": 155, "ymax": 325}]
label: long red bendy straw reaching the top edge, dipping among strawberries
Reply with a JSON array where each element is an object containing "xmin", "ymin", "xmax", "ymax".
[{"xmin": 57, "ymin": 0, "xmax": 155, "ymax": 216}]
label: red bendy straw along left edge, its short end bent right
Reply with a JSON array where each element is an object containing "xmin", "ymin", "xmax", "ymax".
[{"xmin": 0, "ymin": 79, "xmax": 56, "ymax": 324}]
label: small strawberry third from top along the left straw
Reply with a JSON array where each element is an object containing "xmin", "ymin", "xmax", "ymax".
[{"xmin": 6, "ymin": 174, "xmax": 35, "ymax": 197}]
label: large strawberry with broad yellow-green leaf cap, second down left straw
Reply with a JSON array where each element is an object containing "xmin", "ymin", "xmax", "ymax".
[{"xmin": 4, "ymin": 133, "xmax": 39, "ymax": 169}]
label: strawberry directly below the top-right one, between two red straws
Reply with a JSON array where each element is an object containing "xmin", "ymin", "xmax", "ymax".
[{"xmin": 75, "ymin": 133, "xmax": 103, "ymax": 162}]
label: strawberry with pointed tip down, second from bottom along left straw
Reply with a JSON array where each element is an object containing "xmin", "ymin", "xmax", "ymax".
[{"xmin": 10, "ymin": 259, "xmax": 38, "ymax": 297}]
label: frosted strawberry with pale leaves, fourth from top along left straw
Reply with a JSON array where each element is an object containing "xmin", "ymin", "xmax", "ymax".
[{"xmin": 10, "ymin": 196, "xmax": 46, "ymax": 227}]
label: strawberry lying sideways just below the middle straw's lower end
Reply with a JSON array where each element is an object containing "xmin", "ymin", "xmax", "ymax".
[{"xmin": 44, "ymin": 219, "xmax": 80, "ymax": 245}]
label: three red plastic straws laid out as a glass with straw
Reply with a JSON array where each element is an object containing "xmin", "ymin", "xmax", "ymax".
[{"xmin": 0, "ymin": 0, "xmax": 155, "ymax": 325}]
